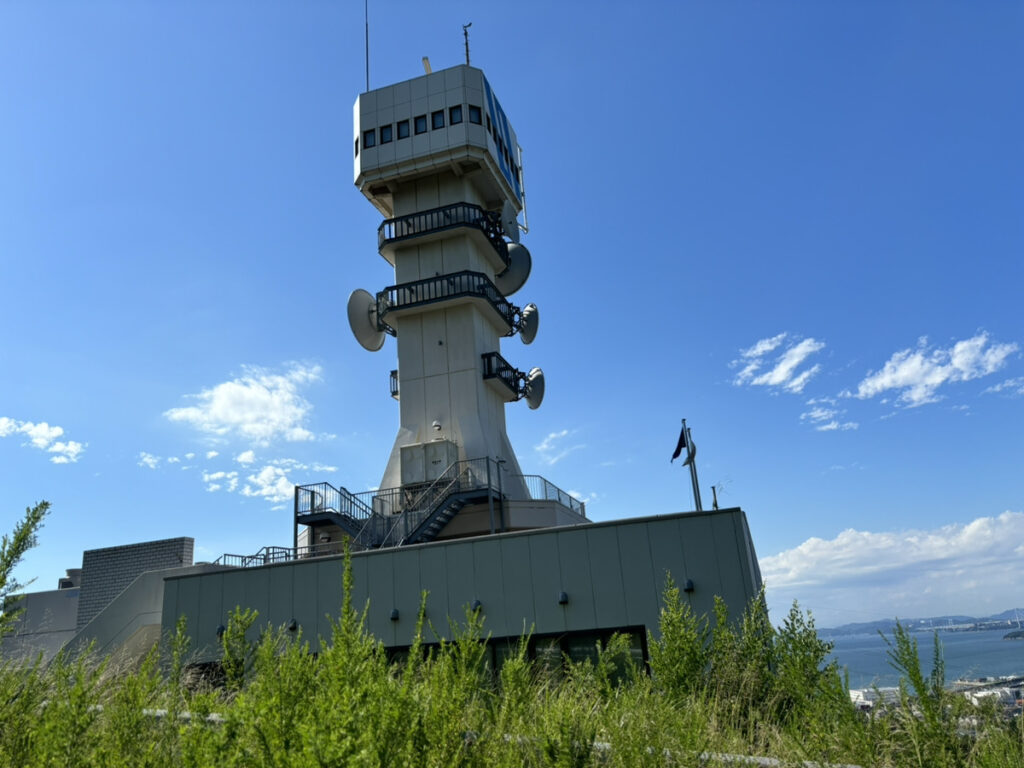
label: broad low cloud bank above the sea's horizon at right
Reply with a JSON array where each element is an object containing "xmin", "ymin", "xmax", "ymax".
[{"xmin": 760, "ymin": 511, "xmax": 1024, "ymax": 626}]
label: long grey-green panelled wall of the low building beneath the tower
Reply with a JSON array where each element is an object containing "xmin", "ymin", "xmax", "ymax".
[{"xmin": 162, "ymin": 509, "xmax": 761, "ymax": 659}]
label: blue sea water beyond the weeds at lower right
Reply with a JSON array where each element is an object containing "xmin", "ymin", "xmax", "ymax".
[{"xmin": 819, "ymin": 630, "xmax": 1024, "ymax": 688}]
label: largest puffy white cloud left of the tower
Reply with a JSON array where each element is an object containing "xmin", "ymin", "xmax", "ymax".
[{"xmin": 164, "ymin": 364, "xmax": 321, "ymax": 445}]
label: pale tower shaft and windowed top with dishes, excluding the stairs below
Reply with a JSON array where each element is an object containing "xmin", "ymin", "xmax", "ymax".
[{"xmin": 348, "ymin": 66, "xmax": 544, "ymax": 500}]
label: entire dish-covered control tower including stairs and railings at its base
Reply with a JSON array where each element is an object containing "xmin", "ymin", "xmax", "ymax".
[{"xmin": 296, "ymin": 65, "xmax": 586, "ymax": 547}]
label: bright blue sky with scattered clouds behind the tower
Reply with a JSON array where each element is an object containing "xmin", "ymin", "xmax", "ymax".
[{"xmin": 0, "ymin": 0, "xmax": 1024, "ymax": 626}]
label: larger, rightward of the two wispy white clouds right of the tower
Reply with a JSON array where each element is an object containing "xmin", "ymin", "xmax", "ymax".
[{"xmin": 856, "ymin": 332, "xmax": 1019, "ymax": 408}]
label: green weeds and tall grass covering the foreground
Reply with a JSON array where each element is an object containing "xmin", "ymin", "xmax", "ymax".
[{"xmin": 0, "ymin": 574, "xmax": 1024, "ymax": 768}]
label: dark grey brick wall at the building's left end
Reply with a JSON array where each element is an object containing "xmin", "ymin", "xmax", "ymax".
[{"xmin": 78, "ymin": 537, "xmax": 196, "ymax": 629}]
